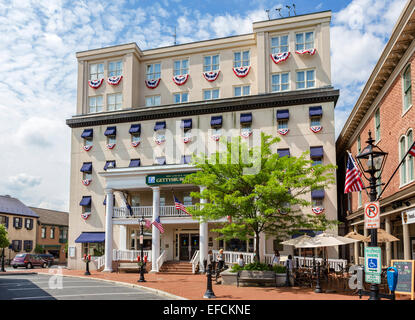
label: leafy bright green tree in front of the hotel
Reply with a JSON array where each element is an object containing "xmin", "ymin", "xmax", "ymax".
[{"xmin": 184, "ymin": 133, "xmax": 337, "ymax": 260}]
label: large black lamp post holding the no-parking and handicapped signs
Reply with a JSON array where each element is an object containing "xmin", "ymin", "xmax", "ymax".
[{"xmin": 356, "ymin": 130, "xmax": 388, "ymax": 300}]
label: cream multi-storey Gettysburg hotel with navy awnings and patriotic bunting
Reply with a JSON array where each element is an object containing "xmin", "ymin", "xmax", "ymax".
[{"xmin": 67, "ymin": 12, "xmax": 339, "ymax": 271}]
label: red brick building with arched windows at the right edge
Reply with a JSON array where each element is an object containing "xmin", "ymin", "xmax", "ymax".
[{"xmin": 336, "ymin": 1, "xmax": 415, "ymax": 265}]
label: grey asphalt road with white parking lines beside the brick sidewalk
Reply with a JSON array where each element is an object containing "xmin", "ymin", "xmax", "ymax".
[{"xmin": 0, "ymin": 274, "xmax": 168, "ymax": 300}]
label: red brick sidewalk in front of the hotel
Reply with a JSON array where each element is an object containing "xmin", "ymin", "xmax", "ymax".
[{"xmin": 24, "ymin": 269, "xmax": 367, "ymax": 300}]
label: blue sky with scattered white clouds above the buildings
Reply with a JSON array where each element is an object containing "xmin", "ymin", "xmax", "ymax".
[{"xmin": 0, "ymin": 0, "xmax": 406, "ymax": 210}]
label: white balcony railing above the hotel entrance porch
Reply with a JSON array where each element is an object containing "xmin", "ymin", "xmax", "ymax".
[{"xmin": 112, "ymin": 205, "xmax": 196, "ymax": 219}]
